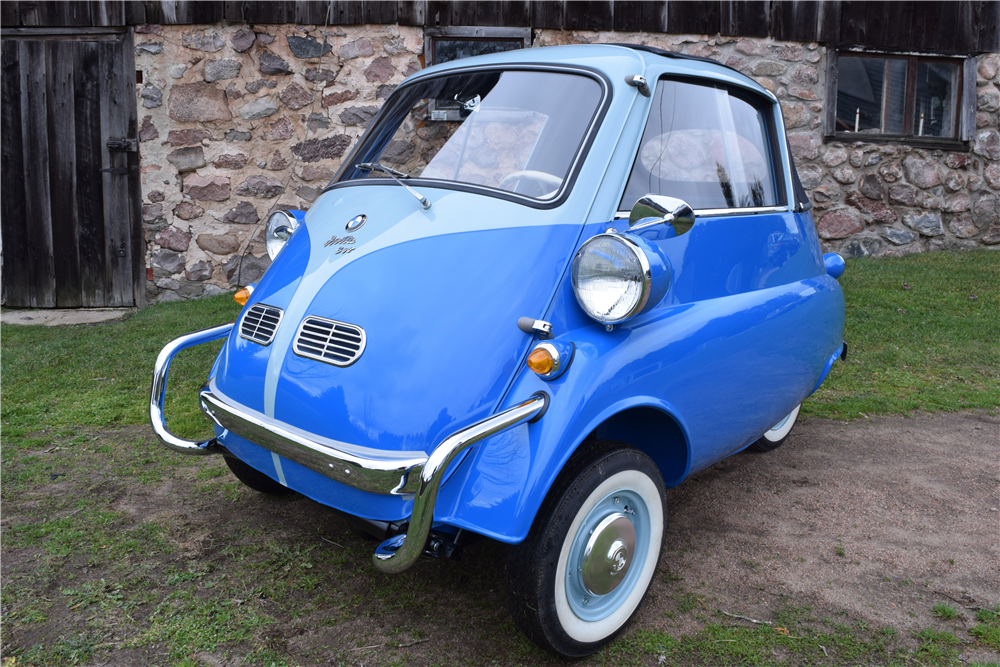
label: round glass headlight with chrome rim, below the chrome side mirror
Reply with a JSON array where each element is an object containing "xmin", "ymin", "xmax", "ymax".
[{"xmin": 573, "ymin": 234, "xmax": 651, "ymax": 324}]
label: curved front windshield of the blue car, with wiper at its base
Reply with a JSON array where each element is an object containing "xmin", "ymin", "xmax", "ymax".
[{"xmin": 340, "ymin": 70, "xmax": 601, "ymax": 201}]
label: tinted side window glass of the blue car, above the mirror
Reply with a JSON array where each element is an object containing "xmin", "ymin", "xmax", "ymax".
[{"xmin": 618, "ymin": 79, "xmax": 780, "ymax": 211}]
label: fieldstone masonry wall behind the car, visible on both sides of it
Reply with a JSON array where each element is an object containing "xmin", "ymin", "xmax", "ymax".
[{"xmin": 136, "ymin": 25, "xmax": 1000, "ymax": 303}]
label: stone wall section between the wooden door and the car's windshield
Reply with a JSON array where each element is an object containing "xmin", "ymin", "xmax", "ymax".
[{"xmin": 136, "ymin": 25, "xmax": 423, "ymax": 303}]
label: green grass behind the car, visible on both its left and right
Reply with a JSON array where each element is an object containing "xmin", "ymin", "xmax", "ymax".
[{"xmin": 0, "ymin": 251, "xmax": 1000, "ymax": 438}]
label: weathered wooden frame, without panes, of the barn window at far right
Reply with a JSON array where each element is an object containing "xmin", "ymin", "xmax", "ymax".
[{"xmin": 823, "ymin": 48, "xmax": 976, "ymax": 151}]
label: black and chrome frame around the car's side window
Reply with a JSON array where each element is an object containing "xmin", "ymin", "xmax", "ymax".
[{"xmin": 614, "ymin": 72, "xmax": 794, "ymax": 219}]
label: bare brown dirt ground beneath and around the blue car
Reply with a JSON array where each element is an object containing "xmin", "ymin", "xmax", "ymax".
[{"xmin": 2, "ymin": 413, "xmax": 1000, "ymax": 665}]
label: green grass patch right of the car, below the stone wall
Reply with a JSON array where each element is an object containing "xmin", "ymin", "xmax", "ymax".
[{"xmin": 802, "ymin": 251, "xmax": 1000, "ymax": 419}]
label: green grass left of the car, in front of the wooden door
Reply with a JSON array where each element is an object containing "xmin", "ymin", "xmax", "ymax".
[{"xmin": 0, "ymin": 295, "xmax": 240, "ymax": 438}]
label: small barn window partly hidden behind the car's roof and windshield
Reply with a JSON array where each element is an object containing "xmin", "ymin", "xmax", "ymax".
[{"xmin": 424, "ymin": 27, "xmax": 531, "ymax": 121}]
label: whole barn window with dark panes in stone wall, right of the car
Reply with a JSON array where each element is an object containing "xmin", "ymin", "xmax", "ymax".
[{"xmin": 826, "ymin": 51, "xmax": 976, "ymax": 144}]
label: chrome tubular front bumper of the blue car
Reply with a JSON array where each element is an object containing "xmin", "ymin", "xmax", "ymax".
[{"xmin": 149, "ymin": 323, "xmax": 548, "ymax": 572}]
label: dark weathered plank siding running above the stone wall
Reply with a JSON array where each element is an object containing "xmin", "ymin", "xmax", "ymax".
[{"xmin": 0, "ymin": 0, "xmax": 1000, "ymax": 54}]
